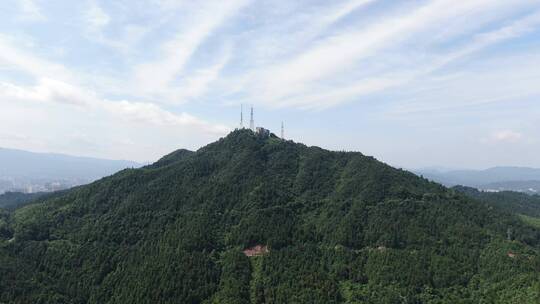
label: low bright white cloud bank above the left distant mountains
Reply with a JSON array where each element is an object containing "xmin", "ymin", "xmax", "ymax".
[{"xmin": 0, "ymin": 80, "xmax": 230, "ymax": 162}]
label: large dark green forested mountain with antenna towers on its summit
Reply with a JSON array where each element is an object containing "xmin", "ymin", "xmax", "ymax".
[{"xmin": 0, "ymin": 130, "xmax": 540, "ymax": 304}]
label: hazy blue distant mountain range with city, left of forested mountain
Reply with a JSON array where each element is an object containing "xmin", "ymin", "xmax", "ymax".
[{"xmin": 0, "ymin": 148, "xmax": 141, "ymax": 193}]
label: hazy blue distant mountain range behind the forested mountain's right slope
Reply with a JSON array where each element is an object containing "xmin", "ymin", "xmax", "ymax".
[{"xmin": 414, "ymin": 167, "xmax": 540, "ymax": 194}]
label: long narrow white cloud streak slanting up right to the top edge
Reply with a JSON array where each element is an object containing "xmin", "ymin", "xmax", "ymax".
[{"xmin": 251, "ymin": 1, "xmax": 488, "ymax": 99}]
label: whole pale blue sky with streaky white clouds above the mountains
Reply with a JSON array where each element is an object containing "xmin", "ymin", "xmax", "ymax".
[{"xmin": 0, "ymin": 0, "xmax": 540, "ymax": 168}]
